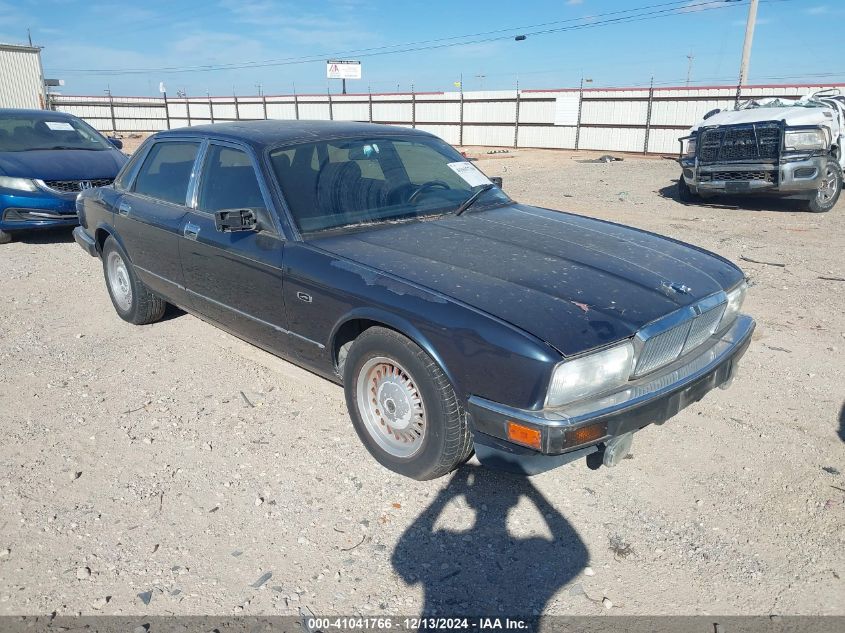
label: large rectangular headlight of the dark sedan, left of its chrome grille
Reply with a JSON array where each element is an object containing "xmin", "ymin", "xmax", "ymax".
[{"xmin": 546, "ymin": 341, "xmax": 634, "ymax": 407}]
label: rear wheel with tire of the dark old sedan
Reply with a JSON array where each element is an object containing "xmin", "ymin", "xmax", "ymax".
[{"xmin": 102, "ymin": 237, "xmax": 167, "ymax": 325}]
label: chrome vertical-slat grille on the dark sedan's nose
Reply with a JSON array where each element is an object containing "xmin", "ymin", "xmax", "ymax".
[{"xmin": 634, "ymin": 299, "xmax": 727, "ymax": 378}]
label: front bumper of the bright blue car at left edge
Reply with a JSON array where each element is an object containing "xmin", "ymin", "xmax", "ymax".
[{"xmin": 0, "ymin": 190, "xmax": 79, "ymax": 231}]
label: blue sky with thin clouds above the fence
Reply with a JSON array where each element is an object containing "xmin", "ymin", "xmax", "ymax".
[{"xmin": 0, "ymin": 0, "xmax": 845, "ymax": 95}]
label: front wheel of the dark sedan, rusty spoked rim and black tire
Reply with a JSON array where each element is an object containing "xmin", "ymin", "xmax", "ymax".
[{"xmin": 343, "ymin": 327, "xmax": 473, "ymax": 480}]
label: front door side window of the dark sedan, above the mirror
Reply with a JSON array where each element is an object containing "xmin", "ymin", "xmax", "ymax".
[{"xmin": 197, "ymin": 145, "xmax": 265, "ymax": 212}]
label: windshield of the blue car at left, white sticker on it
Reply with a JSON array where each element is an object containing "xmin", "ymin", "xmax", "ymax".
[{"xmin": 0, "ymin": 114, "xmax": 112, "ymax": 152}]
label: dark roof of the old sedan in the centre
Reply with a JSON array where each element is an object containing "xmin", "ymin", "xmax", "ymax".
[{"xmin": 156, "ymin": 120, "xmax": 432, "ymax": 148}]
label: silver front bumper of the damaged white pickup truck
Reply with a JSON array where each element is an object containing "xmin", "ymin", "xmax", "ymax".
[{"xmin": 680, "ymin": 154, "xmax": 828, "ymax": 195}]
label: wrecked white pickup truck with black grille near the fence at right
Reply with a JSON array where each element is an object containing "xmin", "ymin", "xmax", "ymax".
[{"xmin": 678, "ymin": 90, "xmax": 845, "ymax": 213}]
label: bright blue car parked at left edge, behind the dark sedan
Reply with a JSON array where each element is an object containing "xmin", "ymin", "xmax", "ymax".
[{"xmin": 0, "ymin": 109, "xmax": 126, "ymax": 244}]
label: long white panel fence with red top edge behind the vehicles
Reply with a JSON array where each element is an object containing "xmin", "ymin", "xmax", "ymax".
[{"xmin": 52, "ymin": 84, "xmax": 845, "ymax": 155}]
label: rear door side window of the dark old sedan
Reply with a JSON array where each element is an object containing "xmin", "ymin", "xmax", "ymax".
[{"xmin": 134, "ymin": 141, "xmax": 199, "ymax": 204}]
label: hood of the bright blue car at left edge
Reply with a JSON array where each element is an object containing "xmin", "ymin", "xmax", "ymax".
[{"xmin": 0, "ymin": 149, "xmax": 127, "ymax": 180}]
